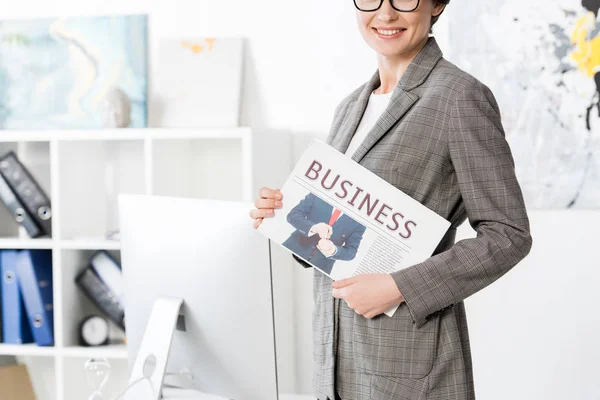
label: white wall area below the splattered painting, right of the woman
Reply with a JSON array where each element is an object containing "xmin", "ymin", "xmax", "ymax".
[{"xmin": 457, "ymin": 210, "xmax": 600, "ymax": 400}]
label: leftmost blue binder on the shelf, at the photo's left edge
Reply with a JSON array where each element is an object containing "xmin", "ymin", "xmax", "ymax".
[{"xmin": 0, "ymin": 250, "xmax": 33, "ymax": 344}]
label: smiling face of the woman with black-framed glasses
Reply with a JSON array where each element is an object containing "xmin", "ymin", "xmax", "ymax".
[{"xmin": 354, "ymin": 0, "xmax": 444, "ymax": 59}]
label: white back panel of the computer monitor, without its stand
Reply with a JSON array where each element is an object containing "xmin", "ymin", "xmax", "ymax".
[{"xmin": 119, "ymin": 195, "xmax": 278, "ymax": 400}]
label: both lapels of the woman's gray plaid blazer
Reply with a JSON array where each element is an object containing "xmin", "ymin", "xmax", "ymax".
[{"xmin": 332, "ymin": 37, "xmax": 442, "ymax": 163}]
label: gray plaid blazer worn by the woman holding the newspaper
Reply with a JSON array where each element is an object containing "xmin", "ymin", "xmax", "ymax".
[{"xmin": 313, "ymin": 37, "xmax": 532, "ymax": 400}]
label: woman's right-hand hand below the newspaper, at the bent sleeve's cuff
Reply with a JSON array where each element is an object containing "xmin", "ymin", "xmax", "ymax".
[{"xmin": 333, "ymin": 274, "xmax": 404, "ymax": 318}]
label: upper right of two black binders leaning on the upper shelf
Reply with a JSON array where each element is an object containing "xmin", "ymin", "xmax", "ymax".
[{"xmin": 0, "ymin": 151, "xmax": 52, "ymax": 236}]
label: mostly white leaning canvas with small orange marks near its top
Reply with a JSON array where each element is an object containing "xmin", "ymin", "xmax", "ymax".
[{"xmin": 150, "ymin": 37, "xmax": 243, "ymax": 128}]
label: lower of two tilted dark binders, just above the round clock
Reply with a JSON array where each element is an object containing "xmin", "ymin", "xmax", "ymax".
[{"xmin": 75, "ymin": 266, "xmax": 125, "ymax": 331}]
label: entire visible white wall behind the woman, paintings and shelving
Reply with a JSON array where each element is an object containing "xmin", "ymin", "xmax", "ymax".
[{"xmin": 0, "ymin": 0, "xmax": 600, "ymax": 400}]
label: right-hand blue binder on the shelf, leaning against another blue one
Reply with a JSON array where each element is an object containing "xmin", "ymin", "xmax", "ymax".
[{"xmin": 17, "ymin": 250, "xmax": 54, "ymax": 346}]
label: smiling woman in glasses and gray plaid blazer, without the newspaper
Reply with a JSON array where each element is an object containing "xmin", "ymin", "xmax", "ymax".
[{"xmin": 250, "ymin": 0, "xmax": 532, "ymax": 400}]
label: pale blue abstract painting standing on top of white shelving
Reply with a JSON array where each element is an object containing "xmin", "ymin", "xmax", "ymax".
[{"xmin": 0, "ymin": 15, "xmax": 148, "ymax": 129}]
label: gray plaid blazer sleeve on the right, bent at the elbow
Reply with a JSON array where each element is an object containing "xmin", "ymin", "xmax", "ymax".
[{"xmin": 391, "ymin": 81, "xmax": 532, "ymax": 328}]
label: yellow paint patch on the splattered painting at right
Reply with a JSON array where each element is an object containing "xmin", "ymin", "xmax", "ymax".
[{"xmin": 571, "ymin": 12, "xmax": 600, "ymax": 77}]
